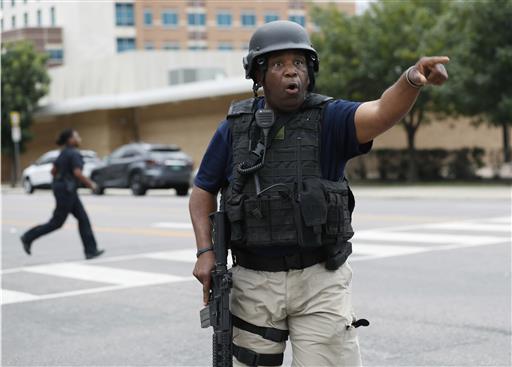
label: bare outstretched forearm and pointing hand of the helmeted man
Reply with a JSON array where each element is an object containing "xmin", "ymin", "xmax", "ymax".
[{"xmin": 354, "ymin": 56, "xmax": 450, "ymax": 144}]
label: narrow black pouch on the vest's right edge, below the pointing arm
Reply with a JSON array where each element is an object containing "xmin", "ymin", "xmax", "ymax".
[{"xmin": 322, "ymin": 180, "xmax": 354, "ymax": 241}]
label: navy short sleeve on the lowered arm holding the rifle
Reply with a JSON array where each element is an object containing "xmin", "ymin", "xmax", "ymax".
[{"xmin": 194, "ymin": 120, "xmax": 233, "ymax": 195}]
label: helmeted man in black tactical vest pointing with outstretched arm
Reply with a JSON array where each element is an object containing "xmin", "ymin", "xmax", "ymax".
[{"xmin": 189, "ymin": 21, "xmax": 448, "ymax": 366}]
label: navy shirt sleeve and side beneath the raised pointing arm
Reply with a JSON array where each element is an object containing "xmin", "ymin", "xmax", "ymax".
[{"xmin": 320, "ymin": 99, "xmax": 373, "ymax": 180}]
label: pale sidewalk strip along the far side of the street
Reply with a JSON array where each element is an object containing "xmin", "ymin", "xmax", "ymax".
[{"xmin": 2, "ymin": 184, "xmax": 512, "ymax": 201}]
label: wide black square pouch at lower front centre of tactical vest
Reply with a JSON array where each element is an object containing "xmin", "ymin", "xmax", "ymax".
[{"xmin": 243, "ymin": 193, "xmax": 297, "ymax": 246}]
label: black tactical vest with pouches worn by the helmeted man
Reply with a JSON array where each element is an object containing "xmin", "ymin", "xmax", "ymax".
[{"xmin": 223, "ymin": 94, "xmax": 353, "ymax": 249}]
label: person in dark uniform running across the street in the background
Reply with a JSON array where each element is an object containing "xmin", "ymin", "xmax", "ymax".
[{"xmin": 21, "ymin": 129, "xmax": 104, "ymax": 260}]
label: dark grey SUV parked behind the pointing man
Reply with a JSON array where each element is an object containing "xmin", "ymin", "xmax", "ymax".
[{"xmin": 91, "ymin": 143, "xmax": 193, "ymax": 196}]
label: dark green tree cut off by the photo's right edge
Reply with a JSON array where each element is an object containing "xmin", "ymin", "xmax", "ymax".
[{"xmin": 441, "ymin": 0, "xmax": 512, "ymax": 162}]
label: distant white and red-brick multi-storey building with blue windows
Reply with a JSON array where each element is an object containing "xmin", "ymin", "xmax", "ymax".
[{"xmin": 0, "ymin": 0, "xmax": 357, "ymax": 66}]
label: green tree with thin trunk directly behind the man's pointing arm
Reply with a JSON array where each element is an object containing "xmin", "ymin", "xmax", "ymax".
[{"xmin": 313, "ymin": 0, "xmax": 449, "ymax": 180}]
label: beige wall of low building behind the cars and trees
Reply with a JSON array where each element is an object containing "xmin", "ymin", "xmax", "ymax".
[{"xmin": 2, "ymin": 92, "xmax": 502, "ymax": 180}]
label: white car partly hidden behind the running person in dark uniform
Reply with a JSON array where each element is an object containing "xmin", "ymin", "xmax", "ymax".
[{"xmin": 22, "ymin": 150, "xmax": 101, "ymax": 194}]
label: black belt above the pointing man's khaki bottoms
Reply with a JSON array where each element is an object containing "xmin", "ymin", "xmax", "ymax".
[{"xmin": 232, "ymin": 248, "xmax": 327, "ymax": 272}]
